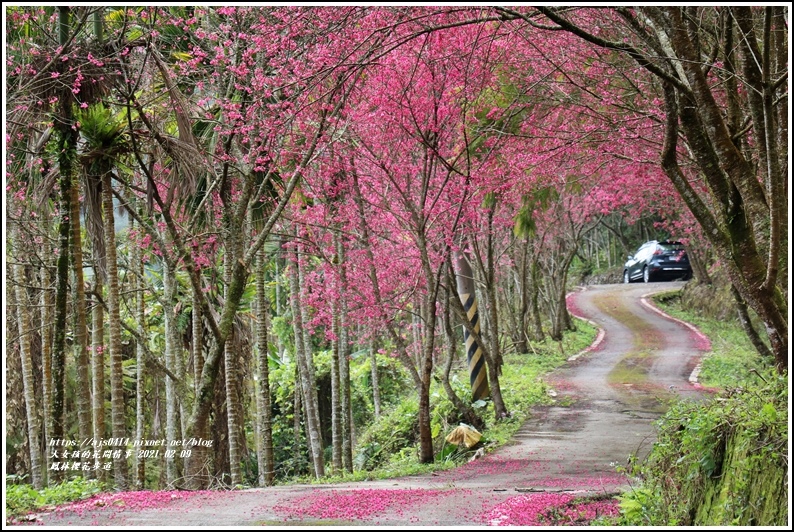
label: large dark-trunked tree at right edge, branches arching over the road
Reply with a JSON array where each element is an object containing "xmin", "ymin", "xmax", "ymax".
[{"xmin": 495, "ymin": 6, "xmax": 788, "ymax": 371}]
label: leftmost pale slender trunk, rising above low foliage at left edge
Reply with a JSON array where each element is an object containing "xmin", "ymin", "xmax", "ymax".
[{"xmin": 14, "ymin": 262, "xmax": 43, "ymax": 489}]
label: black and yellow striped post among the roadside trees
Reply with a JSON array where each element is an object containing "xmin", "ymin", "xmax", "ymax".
[{"xmin": 455, "ymin": 251, "xmax": 491, "ymax": 401}]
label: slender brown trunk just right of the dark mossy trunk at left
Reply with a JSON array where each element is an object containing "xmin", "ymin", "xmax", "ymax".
[{"xmin": 69, "ymin": 180, "xmax": 93, "ymax": 464}]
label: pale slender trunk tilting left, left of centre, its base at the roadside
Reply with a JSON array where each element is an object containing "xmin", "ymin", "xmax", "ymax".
[{"xmin": 290, "ymin": 245, "xmax": 325, "ymax": 478}]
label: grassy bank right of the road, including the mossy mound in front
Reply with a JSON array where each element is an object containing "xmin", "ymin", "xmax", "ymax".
[{"xmin": 608, "ymin": 292, "xmax": 789, "ymax": 526}]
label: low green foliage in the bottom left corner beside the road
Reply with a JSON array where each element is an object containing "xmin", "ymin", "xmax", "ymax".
[{"xmin": 5, "ymin": 475, "xmax": 101, "ymax": 517}]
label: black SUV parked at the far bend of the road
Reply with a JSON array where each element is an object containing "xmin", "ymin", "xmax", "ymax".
[{"xmin": 623, "ymin": 240, "xmax": 692, "ymax": 283}]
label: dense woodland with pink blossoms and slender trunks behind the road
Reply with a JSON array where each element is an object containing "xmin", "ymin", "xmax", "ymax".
[{"xmin": 4, "ymin": 6, "xmax": 789, "ymax": 489}]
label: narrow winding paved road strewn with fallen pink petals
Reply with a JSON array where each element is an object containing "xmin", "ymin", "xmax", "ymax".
[{"xmin": 34, "ymin": 283, "xmax": 708, "ymax": 527}]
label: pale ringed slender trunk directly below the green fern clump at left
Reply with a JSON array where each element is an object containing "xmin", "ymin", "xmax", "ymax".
[{"xmin": 102, "ymin": 171, "xmax": 129, "ymax": 490}]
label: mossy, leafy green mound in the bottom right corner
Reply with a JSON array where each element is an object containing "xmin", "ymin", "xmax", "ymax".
[{"xmin": 621, "ymin": 370, "xmax": 788, "ymax": 526}]
